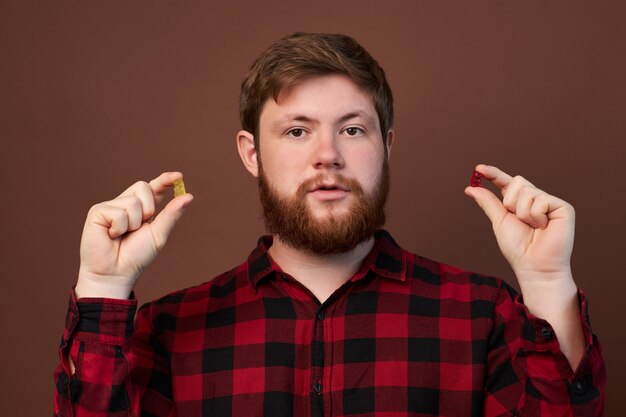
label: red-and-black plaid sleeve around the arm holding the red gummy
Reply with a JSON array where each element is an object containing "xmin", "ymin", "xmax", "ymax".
[{"xmin": 485, "ymin": 283, "xmax": 606, "ymax": 417}]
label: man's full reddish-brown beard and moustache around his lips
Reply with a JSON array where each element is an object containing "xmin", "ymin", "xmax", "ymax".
[{"xmin": 258, "ymin": 158, "xmax": 390, "ymax": 255}]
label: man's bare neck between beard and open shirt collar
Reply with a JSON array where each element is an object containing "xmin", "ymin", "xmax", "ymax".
[{"xmin": 268, "ymin": 236, "xmax": 374, "ymax": 303}]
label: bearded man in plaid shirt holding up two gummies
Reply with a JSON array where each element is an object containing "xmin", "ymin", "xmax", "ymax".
[{"xmin": 55, "ymin": 34, "xmax": 605, "ymax": 416}]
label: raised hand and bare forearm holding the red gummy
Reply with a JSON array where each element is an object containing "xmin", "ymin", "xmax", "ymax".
[{"xmin": 465, "ymin": 165, "xmax": 585, "ymax": 369}]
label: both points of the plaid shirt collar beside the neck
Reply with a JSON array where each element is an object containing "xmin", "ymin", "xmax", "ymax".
[{"xmin": 247, "ymin": 230, "xmax": 407, "ymax": 292}]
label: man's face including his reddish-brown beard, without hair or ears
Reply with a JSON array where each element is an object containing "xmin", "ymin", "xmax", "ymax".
[{"xmin": 258, "ymin": 75, "xmax": 389, "ymax": 254}]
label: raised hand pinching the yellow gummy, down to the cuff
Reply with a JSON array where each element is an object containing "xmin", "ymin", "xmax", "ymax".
[{"xmin": 75, "ymin": 172, "xmax": 193, "ymax": 299}]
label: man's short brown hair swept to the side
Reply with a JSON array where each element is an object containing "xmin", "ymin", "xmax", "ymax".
[{"xmin": 239, "ymin": 32, "xmax": 393, "ymax": 149}]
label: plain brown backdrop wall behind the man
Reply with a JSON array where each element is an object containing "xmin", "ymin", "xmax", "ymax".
[{"xmin": 0, "ymin": 0, "xmax": 626, "ymax": 416}]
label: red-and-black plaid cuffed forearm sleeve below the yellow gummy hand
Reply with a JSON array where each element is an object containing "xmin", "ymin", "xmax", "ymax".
[{"xmin": 54, "ymin": 291, "xmax": 138, "ymax": 417}]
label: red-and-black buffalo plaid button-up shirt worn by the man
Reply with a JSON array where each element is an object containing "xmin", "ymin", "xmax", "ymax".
[{"xmin": 54, "ymin": 231, "xmax": 605, "ymax": 417}]
